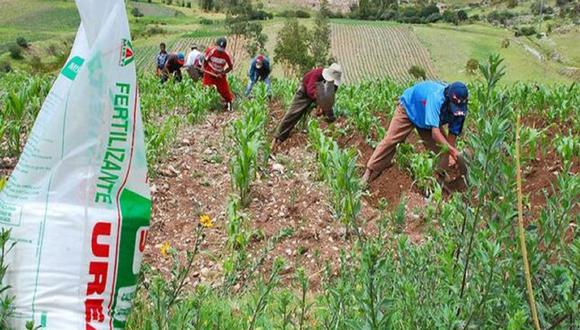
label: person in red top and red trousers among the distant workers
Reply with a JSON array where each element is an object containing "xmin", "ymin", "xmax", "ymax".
[{"xmin": 203, "ymin": 38, "xmax": 234, "ymax": 111}]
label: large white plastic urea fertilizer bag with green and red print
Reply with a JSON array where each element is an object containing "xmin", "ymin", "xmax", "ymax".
[{"xmin": 0, "ymin": 0, "xmax": 151, "ymax": 330}]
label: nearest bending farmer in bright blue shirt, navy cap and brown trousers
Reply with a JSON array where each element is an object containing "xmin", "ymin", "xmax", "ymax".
[{"xmin": 363, "ymin": 81, "xmax": 469, "ymax": 184}]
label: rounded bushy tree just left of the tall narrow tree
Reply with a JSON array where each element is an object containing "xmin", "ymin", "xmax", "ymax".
[{"xmin": 274, "ymin": 18, "xmax": 314, "ymax": 76}]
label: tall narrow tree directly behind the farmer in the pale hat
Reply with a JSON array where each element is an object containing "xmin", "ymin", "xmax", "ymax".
[{"xmin": 310, "ymin": 0, "xmax": 330, "ymax": 66}]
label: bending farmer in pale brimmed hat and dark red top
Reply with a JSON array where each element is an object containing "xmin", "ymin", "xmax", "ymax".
[{"xmin": 272, "ymin": 63, "xmax": 342, "ymax": 152}]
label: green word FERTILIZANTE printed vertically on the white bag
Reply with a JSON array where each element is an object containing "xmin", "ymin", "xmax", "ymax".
[{"xmin": 95, "ymin": 83, "xmax": 131, "ymax": 204}]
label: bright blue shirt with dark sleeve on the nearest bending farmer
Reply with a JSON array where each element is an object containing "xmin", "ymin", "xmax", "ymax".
[{"xmin": 400, "ymin": 81, "xmax": 465, "ymax": 135}]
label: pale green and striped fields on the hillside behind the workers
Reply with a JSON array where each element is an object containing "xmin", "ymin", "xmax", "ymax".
[{"xmin": 0, "ymin": 0, "xmax": 580, "ymax": 82}]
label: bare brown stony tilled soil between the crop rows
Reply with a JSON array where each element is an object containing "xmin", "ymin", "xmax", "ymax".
[{"xmin": 0, "ymin": 102, "xmax": 579, "ymax": 288}]
